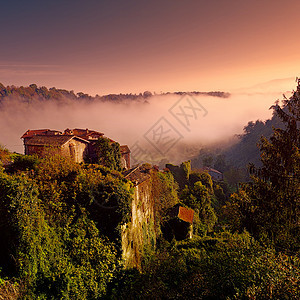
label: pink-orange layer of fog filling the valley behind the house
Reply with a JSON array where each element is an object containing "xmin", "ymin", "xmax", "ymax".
[{"xmin": 0, "ymin": 88, "xmax": 289, "ymax": 163}]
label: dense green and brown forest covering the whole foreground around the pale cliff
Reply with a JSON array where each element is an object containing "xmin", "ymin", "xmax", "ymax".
[{"xmin": 0, "ymin": 83, "xmax": 300, "ymax": 299}]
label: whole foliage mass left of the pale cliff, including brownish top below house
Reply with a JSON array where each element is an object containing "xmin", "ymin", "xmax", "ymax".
[{"xmin": 0, "ymin": 156, "xmax": 130, "ymax": 299}]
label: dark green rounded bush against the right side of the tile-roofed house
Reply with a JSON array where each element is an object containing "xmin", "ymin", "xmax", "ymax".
[{"xmin": 95, "ymin": 137, "xmax": 122, "ymax": 171}]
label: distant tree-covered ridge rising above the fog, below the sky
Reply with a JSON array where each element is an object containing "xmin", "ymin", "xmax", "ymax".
[{"xmin": 0, "ymin": 83, "xmax": 230, "ymax": 103}]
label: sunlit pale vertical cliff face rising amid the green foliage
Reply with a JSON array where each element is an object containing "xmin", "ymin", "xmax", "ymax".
[{"xmin": 122, "ymin": 178, "xmax": 156, "ymax": 269}]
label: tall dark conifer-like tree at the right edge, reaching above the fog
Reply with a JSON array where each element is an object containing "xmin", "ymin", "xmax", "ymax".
[{"xmin": 227, "ymin": 81, "xmax": 300, "ymax": 253}]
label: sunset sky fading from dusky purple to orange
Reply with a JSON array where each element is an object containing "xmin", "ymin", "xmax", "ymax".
[{"xmin": 0, "ymin": 0, "xmax": 300, "ymax": 95}]
